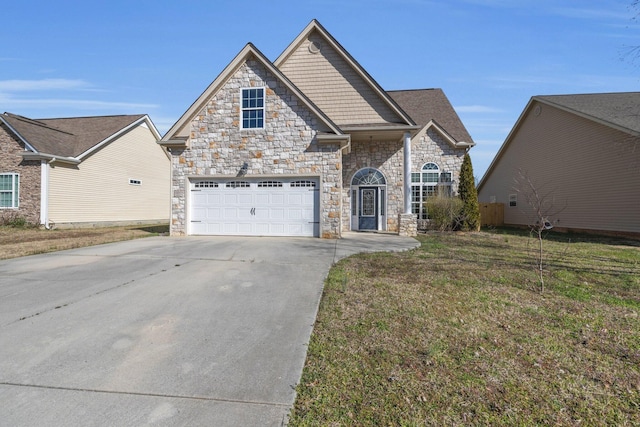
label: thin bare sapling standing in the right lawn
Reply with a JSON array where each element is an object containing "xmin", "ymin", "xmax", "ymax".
[{"xmin": 513, "ymin": 169, "xmax": 566, "ymax": 292}]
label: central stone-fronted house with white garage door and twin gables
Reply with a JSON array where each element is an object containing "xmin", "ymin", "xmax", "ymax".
[{"xmin": 160, "ymin": 20, "xmax": 474, "ymax": 238}]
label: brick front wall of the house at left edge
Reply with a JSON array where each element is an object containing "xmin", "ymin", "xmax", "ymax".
[{"xmin": 0, "ymin": 124, "xmax": 40, "ymax": 224}]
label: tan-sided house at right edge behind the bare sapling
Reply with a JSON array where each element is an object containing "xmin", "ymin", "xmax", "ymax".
[{"xmin": 478, "ymin": 92, "xmax": 640, "ymax": 235}]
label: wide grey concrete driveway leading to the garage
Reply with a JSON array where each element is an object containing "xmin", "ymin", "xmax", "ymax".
[{"xmin": 0, "ymin": 233, "xmax": 418, "ymax": 426}]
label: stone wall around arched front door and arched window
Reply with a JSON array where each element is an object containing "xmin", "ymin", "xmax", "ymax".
[{"xmin": 342, "ymin": 129, "xmax": 465, "ymax": 232}]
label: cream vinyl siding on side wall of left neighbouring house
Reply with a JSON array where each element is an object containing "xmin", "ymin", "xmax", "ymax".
[{"xmin": 49, "ymin": 125, "xmax": 170, "ymax": 224}]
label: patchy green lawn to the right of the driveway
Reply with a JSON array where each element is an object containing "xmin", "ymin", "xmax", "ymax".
[{"xmin": 290, "ymin": 231, "xmax": 640, "ymax": 426}]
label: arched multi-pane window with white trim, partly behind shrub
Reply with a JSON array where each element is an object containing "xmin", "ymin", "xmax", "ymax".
[{"xmin": 411, "ymin": 162, "xmax": 452, "ymax": 219}]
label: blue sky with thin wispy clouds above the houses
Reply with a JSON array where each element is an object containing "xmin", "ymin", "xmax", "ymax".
[{"xmin": 0, "ymin": 0, "xmax": 640, "ymax": 178}]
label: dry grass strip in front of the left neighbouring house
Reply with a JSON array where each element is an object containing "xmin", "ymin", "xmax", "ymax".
[{"xmin": 0, "ymin": 226, "xmax": 168, "ymax": 259}]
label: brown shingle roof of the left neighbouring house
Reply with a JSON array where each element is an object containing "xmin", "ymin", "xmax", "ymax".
[{"xmin": 2, "ymin": 113, "xmax": 144, "ymax": 157}]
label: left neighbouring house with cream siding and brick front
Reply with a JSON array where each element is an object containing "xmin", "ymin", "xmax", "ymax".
[{"xmin": 0, "ymin": 113, "xmax": 170, "ymax": 227}]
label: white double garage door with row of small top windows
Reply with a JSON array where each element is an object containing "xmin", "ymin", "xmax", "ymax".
[{"xmin": 189, "ymin": 178, "xmax": 320, "ymax": 237}]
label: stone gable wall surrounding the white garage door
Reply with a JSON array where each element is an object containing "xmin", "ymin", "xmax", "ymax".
[{"xmin": 171, "ymin": 59, "xmax": 342, "ymax": 238}]
